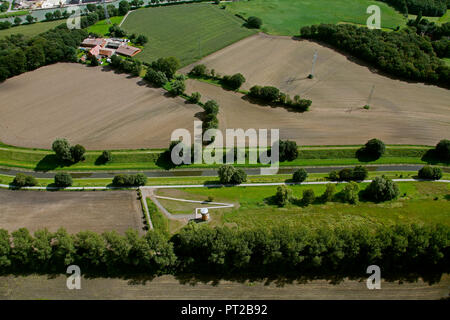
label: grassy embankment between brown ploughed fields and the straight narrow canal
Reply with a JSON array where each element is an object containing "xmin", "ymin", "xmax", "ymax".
[{"xmin": 0, "ymin": 144, "xmax": 445, "ymax": 171}]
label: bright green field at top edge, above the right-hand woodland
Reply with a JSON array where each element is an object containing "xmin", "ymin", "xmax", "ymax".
[{"xmin": 226, "ymin": 0, "xmax": 406, "ymax": 36}]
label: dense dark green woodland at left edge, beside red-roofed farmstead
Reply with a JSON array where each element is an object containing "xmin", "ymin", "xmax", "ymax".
[{"xmin": 0, "ymin": 25, "xmax": 88, "ymax": 81}]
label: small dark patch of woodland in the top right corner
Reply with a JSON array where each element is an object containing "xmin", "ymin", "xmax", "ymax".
[{"xmin": 380, "ymin": 0, "xmax": 450, "ymax": 17}]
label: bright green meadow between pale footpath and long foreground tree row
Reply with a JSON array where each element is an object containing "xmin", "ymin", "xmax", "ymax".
[{"xmin": 158, "ymin": 182, "xmax": 450, "ymax": 228}]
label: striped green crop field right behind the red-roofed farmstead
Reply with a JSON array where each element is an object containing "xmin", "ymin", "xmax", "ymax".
[{"xmin": 122, "ymin": 4, "xmax": 255, "ymax": 66}]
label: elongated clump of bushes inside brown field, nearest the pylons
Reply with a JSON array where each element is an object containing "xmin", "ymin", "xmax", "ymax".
[{"xmin": 248, "ymin": 85, "xmax": 312, "ymax": 112}]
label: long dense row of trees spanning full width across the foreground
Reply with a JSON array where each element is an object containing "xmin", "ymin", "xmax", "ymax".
[{"xmin": 0, "ymin": 223, "xmax": 450, "ymax": 277}]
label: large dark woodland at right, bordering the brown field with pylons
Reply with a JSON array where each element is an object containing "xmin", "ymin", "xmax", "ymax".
[{"xmin": 300, "ymin": 24, "xmax": 450, "ymax": 85}]
